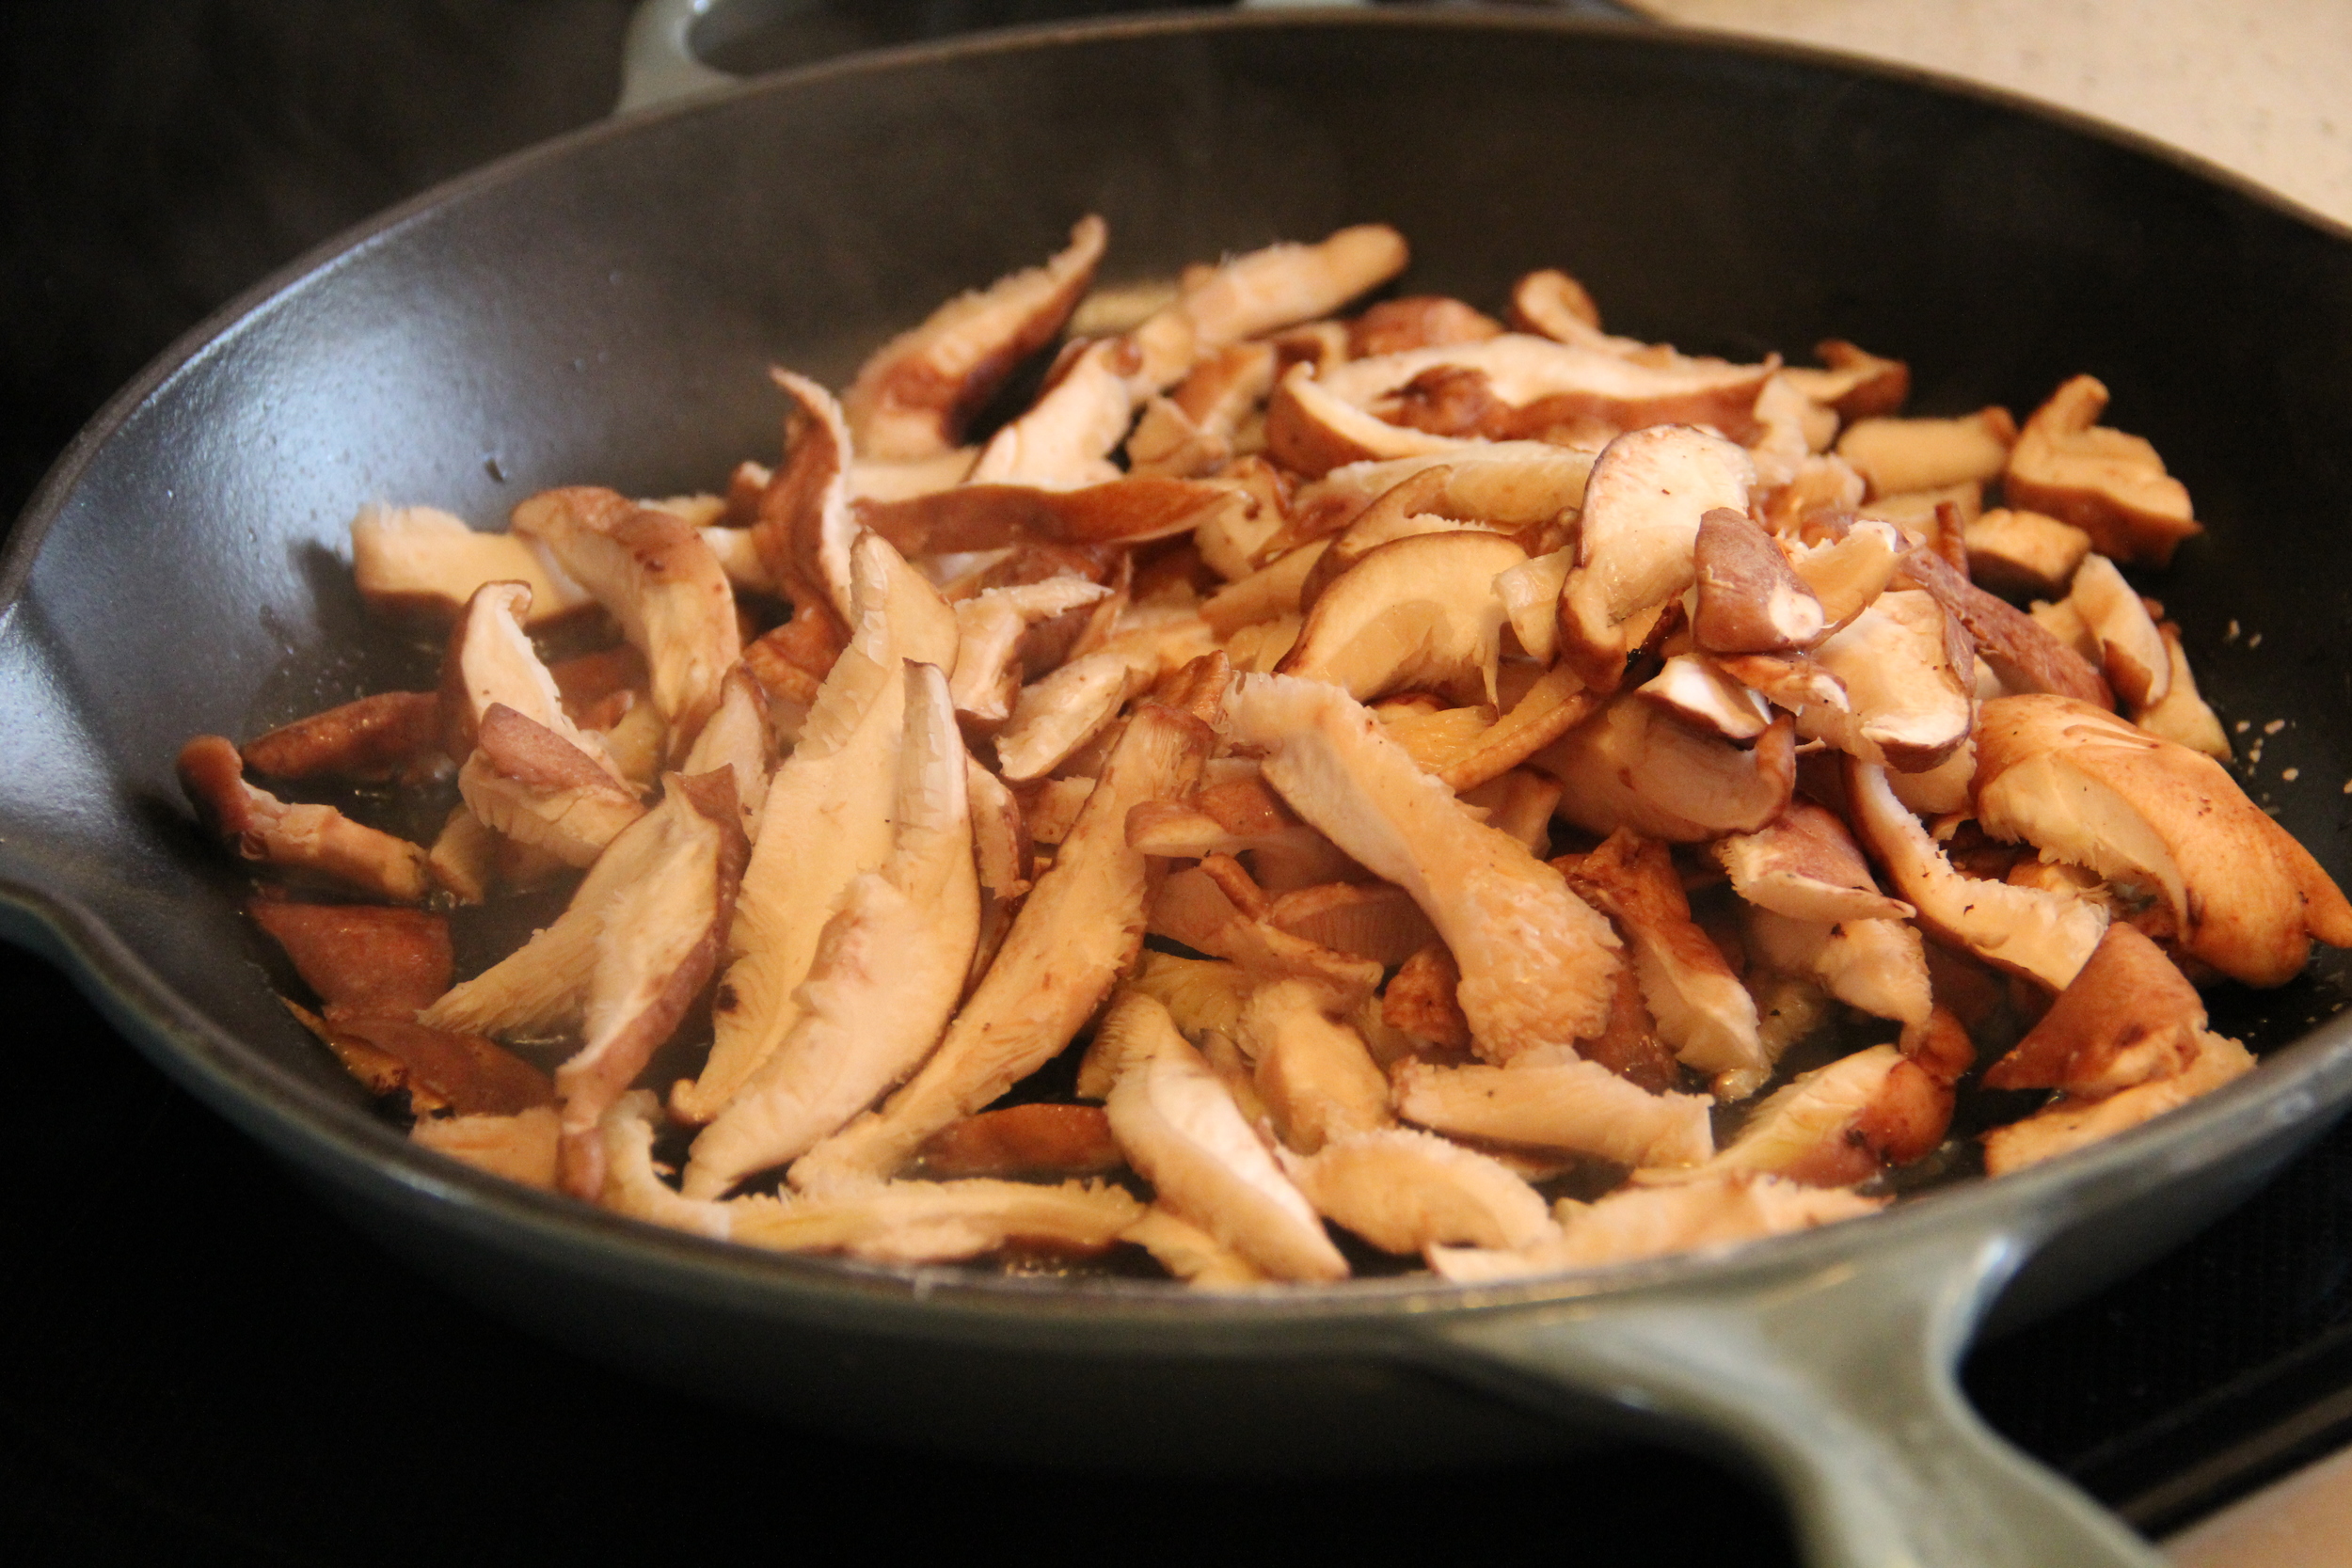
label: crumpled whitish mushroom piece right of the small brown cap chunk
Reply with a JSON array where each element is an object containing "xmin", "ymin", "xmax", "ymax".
[{"xmin": 1797, "ymin": 588, "xmax": 1976, "ymax": 773}]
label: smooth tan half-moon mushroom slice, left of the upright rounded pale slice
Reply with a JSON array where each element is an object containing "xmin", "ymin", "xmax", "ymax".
[{"xmin": 1278, "ymin": 531, "xmax": 1527, "ymax": 703}]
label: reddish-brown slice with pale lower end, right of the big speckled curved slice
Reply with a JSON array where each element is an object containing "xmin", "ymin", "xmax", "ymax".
[{"xmin": 1569, "ymin": 828, "xmax": 1772, "ymax": 1101}]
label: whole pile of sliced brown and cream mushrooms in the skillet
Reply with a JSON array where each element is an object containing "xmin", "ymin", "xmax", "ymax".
[{"xmin": 182, "ymin": 218, "xmax": 2352, "ymax": 1286}]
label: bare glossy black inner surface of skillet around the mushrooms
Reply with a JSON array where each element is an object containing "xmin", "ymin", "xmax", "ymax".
[{"xmin": 0, "ymin": 6, "xmax": 2352, "ymax": 1476}]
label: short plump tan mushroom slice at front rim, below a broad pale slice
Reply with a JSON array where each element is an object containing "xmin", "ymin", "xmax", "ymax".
[{"xmin": 1282, "ymin": 1129, "xmax": 1560, "ymax": 1256}]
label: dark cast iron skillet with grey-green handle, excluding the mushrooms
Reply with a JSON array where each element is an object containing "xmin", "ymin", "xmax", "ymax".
[{"xmin": 0, "ymin": 14, "xmax": 2352, "ymax": 1568}]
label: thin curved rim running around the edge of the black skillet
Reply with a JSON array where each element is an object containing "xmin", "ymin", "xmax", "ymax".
[{"xmin": 0, "ymin": 9, "xmax": 2352, "ymax": 1350}]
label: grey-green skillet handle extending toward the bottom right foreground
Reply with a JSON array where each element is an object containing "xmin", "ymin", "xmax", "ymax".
[{"xmin": 1425, "ymin": 1232, "xmax": 2164, "ymax": 1568}]
